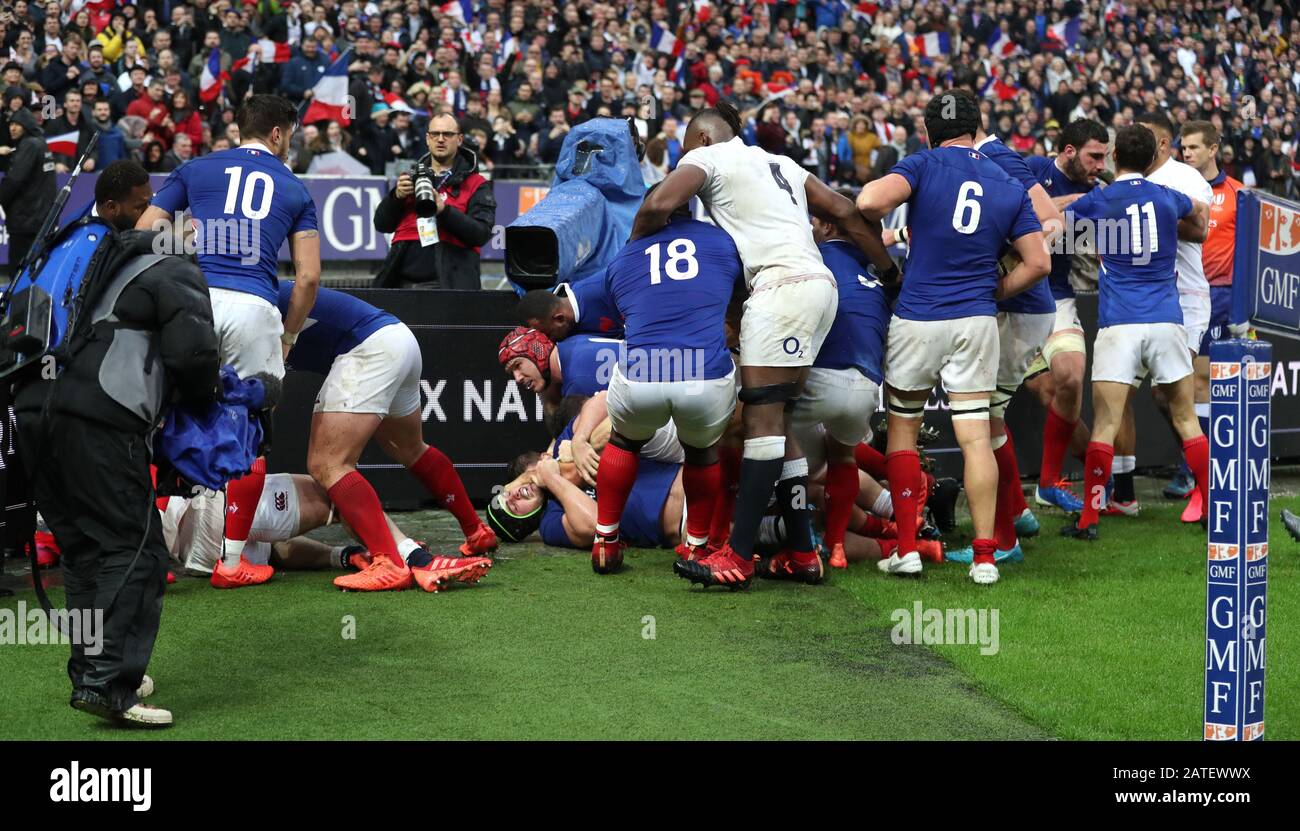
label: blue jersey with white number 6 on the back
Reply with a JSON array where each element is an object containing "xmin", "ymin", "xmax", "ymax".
[{"xmin": 891, "ymin": 147, "xmax": 1043, "ymax": 320}]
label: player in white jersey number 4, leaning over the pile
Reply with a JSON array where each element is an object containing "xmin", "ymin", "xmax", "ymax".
[{"xmin": 632, "ymin": 101, "xmax": 897, "ymax": 588}]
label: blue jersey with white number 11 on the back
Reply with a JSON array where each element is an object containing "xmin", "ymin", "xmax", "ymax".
[{"xmin": 1070, "ymin": 173, "xmax": 1192, "ymax": 328}]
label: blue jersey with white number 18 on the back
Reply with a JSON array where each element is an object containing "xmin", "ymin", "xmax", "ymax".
[{"xmin": 605, "ymin": 218, "xmax": 744, "ymax": 381}]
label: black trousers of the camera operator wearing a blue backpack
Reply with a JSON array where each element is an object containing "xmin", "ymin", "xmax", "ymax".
[{"xmin": 18, "ymin": 415, "xmax": 168, "ymax": 710}]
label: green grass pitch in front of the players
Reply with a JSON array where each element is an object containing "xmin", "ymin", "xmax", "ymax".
[{"xmin": 0, "ymin": 475, "xmax": 1300, "ymax": 740}]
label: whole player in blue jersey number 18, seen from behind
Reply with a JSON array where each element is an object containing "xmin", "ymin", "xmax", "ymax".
[{"xmin": 592, "ymin": 189, "xmax": 743, "ymax": 577}]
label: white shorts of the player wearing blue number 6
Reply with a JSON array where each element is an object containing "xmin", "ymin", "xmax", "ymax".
[{"xmin": 885, "ymin": 315, "xmax": 998, "ymax": 393}]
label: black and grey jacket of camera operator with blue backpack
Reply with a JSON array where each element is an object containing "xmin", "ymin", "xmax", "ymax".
[{"xmin": 14, "ymin": 231, "xmax": 220, "ymax": 434}]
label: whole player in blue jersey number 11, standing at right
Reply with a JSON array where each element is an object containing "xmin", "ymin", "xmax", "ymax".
[{"xmin": 1061, "ymin": 125, "xmax": 1209, "ymax": 540}]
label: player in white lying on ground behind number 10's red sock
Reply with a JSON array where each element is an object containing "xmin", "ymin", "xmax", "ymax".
[{"xmin": 163, "ymin": 473, "xmax": 491, "ymax": 592}]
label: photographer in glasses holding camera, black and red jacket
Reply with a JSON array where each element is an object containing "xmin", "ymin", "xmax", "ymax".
[{"xmin": 374, "ymin": 114, "xmax": 497, "ymax": 290}]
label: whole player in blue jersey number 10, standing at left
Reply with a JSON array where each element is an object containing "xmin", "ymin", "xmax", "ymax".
[{"xmin": 135, "ymin": 95, "xmax": 321, "ymax": 588}]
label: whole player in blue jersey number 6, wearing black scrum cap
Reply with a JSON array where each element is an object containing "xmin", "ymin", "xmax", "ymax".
[{"xmin": 858, "ymin": 90, "xmax": 1050, "ymax": 584}]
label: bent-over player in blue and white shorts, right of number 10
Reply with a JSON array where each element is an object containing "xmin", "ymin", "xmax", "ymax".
[{"xmin": 280, "ymin": 281, "xmax": 497, "ymax": 592}]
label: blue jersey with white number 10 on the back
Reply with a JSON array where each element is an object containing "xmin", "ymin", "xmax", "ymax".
[{"xmin": 153, "ymin": 144, "xmax": 317, "ymax": 304}]
